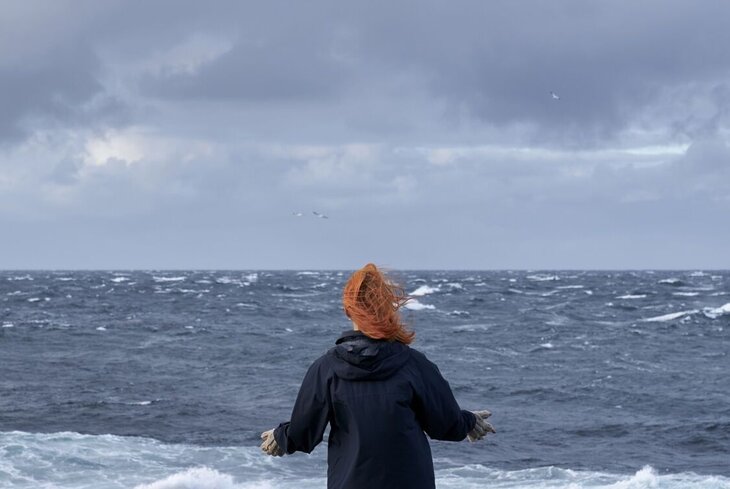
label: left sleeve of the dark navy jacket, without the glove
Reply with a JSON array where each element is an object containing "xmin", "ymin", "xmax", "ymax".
[{"xmin": 274, "ymin": 359, "xmax": 331, "ymax": 453}]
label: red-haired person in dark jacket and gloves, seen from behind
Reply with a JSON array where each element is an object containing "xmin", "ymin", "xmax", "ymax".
[{"xmin": 261, "ymin": 263, "xmax": 494, "ymax": 489}]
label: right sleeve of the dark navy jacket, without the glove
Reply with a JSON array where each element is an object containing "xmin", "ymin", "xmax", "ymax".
[{"xmin": 413, "ymin": 351, "xmax": 476, "ymax": 441}]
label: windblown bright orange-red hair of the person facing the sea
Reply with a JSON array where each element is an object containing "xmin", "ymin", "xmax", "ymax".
[{"xmin": 342, "ymin": 263, "xmax": 416, "ymax": 345}]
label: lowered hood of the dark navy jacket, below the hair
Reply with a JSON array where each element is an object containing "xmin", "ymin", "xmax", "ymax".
[{"xmin": 330, "ymin": 331, "xmax": 410, "ymax": 380}]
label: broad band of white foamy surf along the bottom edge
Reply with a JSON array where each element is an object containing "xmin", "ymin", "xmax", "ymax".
[{"xmin": 0, "ymin": 431, "xmax": 730, "ymax": 489}]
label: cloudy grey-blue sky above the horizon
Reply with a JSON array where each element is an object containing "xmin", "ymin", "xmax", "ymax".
[{"xmin": 0, "ymin": 0, "xmax": 730, "ymax": 269}]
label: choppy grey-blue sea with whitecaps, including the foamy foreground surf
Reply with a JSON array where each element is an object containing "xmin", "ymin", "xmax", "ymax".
[{"xmin": 0, "ymin": 270, "xmax": 730, "ymax": 489}]
